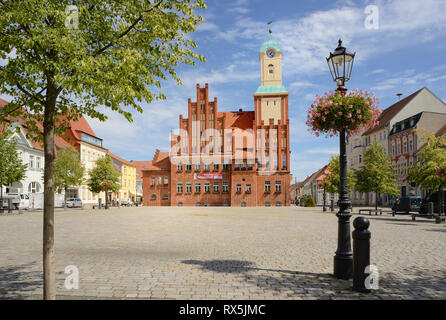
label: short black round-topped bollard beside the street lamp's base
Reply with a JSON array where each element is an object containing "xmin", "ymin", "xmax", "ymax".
[{"xmin": 352, "ymin": 217, "xmax": 371, "ymax": 293}]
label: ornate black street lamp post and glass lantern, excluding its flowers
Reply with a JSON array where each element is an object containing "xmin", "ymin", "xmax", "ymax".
[{"xmin": 327, "ymin": 39, "xmax": 355, "ymax": 279}]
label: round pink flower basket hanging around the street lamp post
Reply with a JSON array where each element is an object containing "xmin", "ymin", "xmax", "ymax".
[{"xmin": 306, "ymin": 89, "xmax": 381, "ymax": 137}]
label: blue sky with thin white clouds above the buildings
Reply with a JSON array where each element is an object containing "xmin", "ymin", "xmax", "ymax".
[{"xmin": 6, "ymin": 0, "xmax": 446, "ymax": 181}]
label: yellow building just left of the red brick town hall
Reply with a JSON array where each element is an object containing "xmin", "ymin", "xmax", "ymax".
[{"xmin": 107, "ymin": 151, "xmax": 136, "ymax": 203}]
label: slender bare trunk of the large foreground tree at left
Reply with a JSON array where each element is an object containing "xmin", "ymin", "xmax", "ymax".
[{"xmin": 43, "ymin": 85, "xmax": 57, "ymax": 300}]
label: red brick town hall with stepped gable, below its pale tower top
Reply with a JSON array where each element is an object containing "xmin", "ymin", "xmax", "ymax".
[{"xmin": 142, "ymin": 84, "xmax": 291, "ymax": 207}]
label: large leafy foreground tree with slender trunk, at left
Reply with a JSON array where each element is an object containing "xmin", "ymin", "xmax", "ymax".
[{"xmin": 0, "ymin": 0, "xmax": 206, "ymax": 299}]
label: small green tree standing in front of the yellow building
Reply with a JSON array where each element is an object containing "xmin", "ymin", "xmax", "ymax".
[{"xmin": 87, "ymin": 155, "xmax": 121, "ymax": 203}]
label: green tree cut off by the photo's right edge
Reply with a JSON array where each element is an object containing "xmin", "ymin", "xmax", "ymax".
[{"xmin": 406, "ymin": 130, "xmax": 446, "ymax": 215}]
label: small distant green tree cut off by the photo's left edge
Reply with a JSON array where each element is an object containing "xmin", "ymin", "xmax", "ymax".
[{"xmin": 0, "ymin": 131, "xmax": 28, "ymax": 204}]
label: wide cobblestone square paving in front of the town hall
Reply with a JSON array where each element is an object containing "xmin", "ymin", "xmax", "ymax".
[{"xmin": 0, "ymin": 207, "xmax": 446, "ymax": 299}]
